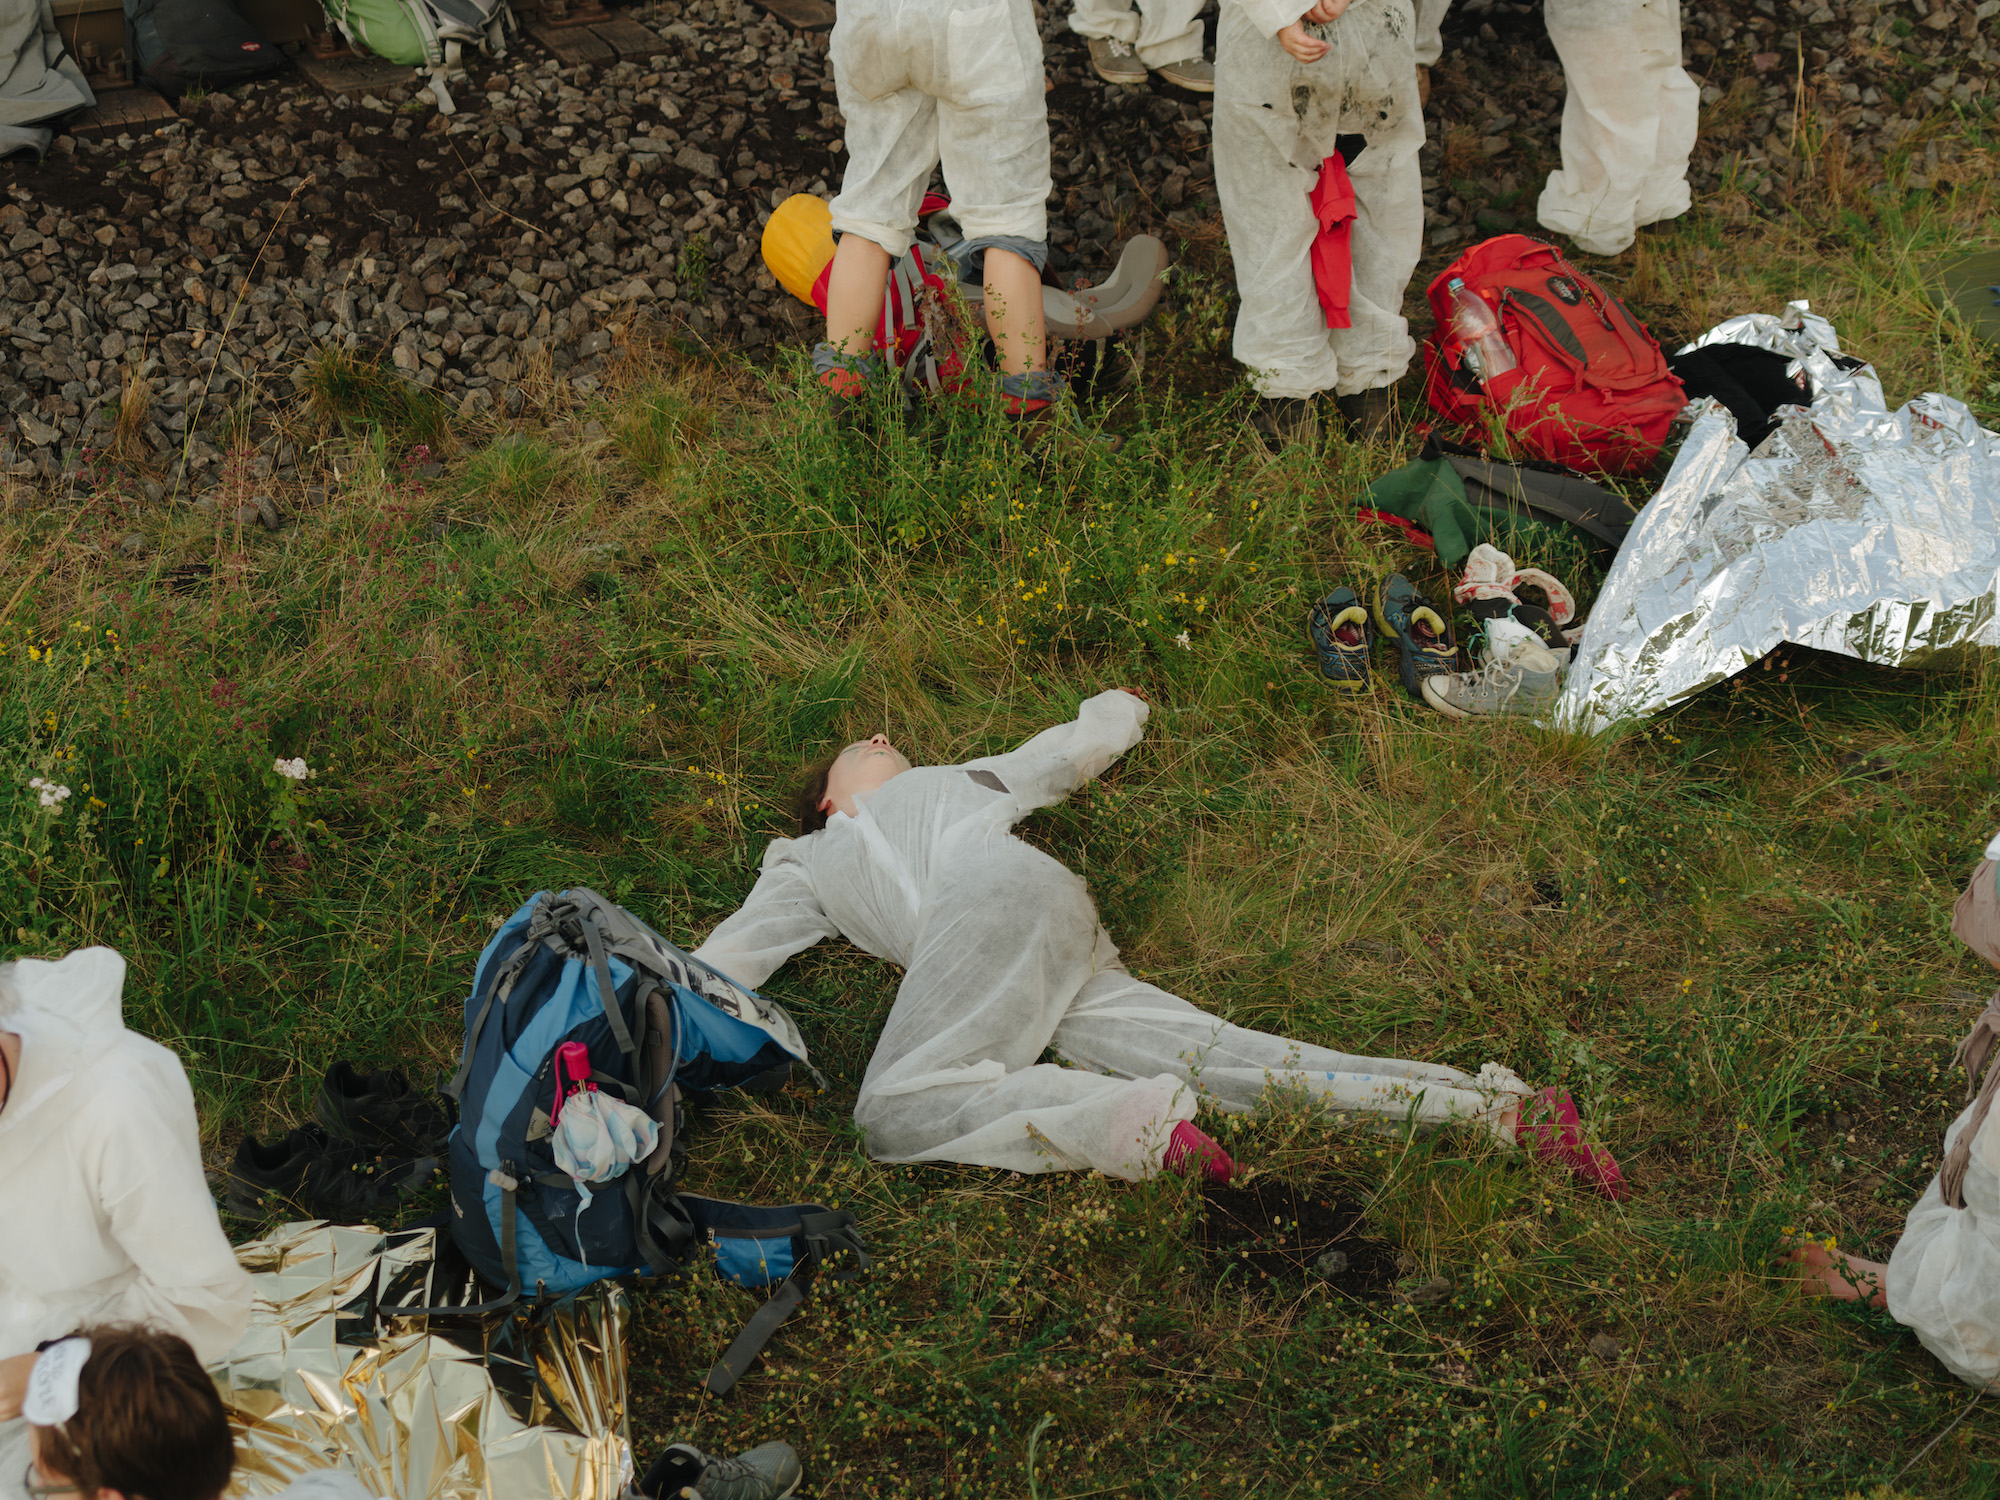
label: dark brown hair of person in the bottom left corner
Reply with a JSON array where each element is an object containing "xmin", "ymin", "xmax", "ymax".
[{"xmin": 40, "ymin": 1326, "xmax": 236, "ymax": 1500}]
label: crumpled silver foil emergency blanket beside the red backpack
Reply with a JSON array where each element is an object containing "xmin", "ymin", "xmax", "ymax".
[{"xmin": 1554, "ymin": 302, "xmax": 2000, "ymax": 732}]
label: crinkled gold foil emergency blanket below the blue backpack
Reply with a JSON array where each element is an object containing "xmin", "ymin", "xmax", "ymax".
[{"xmin": 210, "ymin": 1222, "xmax": 632, "ymax": 1500}]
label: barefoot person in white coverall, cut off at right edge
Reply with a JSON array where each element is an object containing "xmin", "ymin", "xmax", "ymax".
[{"xmin": 1784, "ymin": 836, "xmax": 2000, "ymax": 1390}]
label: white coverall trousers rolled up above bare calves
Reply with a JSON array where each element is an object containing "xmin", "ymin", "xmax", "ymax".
[{"xmin": 828, "ymin": 0, "xmax": 1054, "ymax": 256}]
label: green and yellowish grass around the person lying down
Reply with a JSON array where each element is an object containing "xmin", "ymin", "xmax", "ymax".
[{"xmin": 11, "ymin": 91, "xmax": 2000, "ymax": 1500}]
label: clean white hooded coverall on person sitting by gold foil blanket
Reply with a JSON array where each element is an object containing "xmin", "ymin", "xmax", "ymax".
[{"xmin": 0, "ymin": 948, "xmax": 250, "ymax": 1494}]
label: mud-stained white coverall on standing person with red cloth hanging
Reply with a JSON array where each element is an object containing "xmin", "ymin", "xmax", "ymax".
[{"xmin": 1214, "ymin": 0, "xmax": 1424, "ymax": 398}]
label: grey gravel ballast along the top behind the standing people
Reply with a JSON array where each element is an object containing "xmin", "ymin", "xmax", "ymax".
[{"xmin": 0, "ymin": 0, "xmax": 2000, "ymax": 496}]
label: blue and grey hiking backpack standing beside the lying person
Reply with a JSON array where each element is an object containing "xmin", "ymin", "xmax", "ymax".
[{"xmin": 440, "ymin": 890, "xmax": 868, "ymax": 1394}]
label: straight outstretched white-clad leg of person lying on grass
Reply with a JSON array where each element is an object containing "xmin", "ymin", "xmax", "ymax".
[{"xmin": 1050, "ymin": 966, "xmax": 1528, "ymax": 1140}]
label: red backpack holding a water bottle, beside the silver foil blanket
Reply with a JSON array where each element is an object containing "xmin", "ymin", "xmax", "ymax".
[{"xmin": 1424, "ymin": 234, "xmax": 1688, "ymax": 474}]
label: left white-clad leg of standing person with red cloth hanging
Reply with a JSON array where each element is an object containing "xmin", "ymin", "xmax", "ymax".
[{"xmin": 1214, "ymin": 4, "xmax": 1340, "ymax": 398}]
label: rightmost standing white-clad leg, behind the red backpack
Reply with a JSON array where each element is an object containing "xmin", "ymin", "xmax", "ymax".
[{"xmin": 1536, "ymin": 0, "xmax": 1700, "ymax": 256}]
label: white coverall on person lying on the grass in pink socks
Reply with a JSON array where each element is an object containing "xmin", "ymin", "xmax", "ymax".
[{"xmin": 694, "ymin": 692, "xmax": 1526, "ymax": 1180}]
